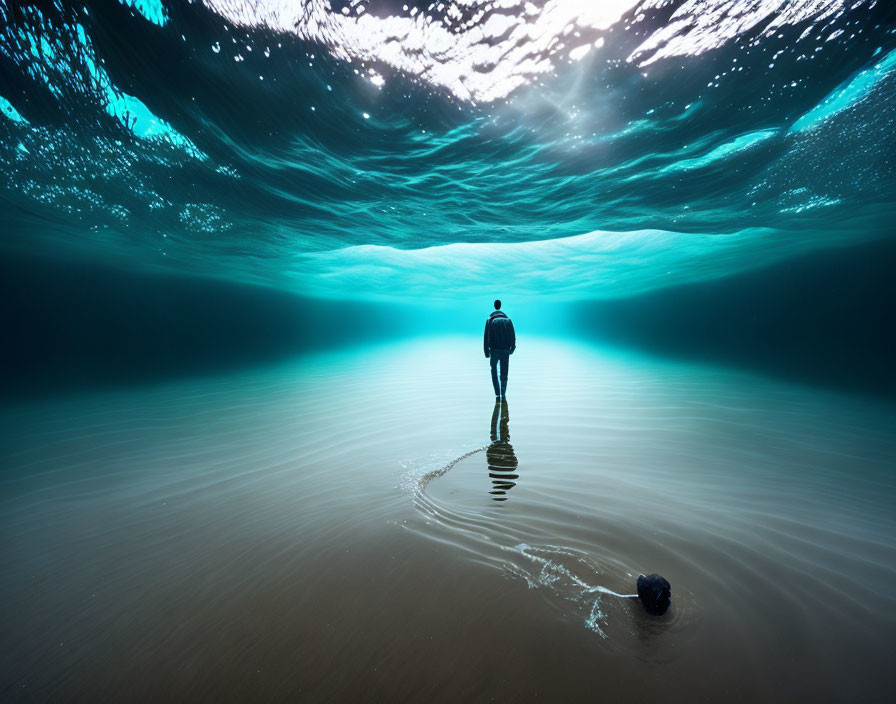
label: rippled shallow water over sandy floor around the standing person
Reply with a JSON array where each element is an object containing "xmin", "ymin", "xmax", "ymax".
[{"xmin": 0, "ymin": 338, "xmax": 896, "ymax": 701}]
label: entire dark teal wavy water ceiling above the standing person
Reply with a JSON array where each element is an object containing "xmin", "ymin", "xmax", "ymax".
[{"xmin": 0, "ymin": 0, "xmax": 896, "ymax": 300}]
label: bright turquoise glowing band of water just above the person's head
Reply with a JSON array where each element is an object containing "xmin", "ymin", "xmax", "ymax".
[{"xmin": 290, "ymin": 228, "xmax": 833, "ymax": 301}]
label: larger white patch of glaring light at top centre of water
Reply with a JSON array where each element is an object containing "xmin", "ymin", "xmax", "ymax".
[{"xmin": 205, "ymin": 0, "xmax": 637, "ymax": 102}]
